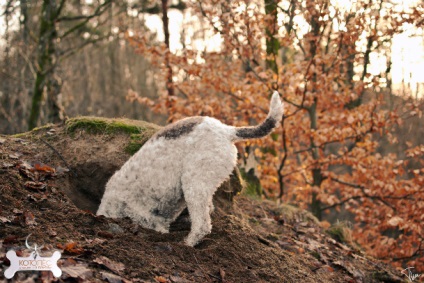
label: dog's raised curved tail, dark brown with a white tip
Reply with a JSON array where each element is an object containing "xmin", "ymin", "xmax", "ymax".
[{"xmin": 232, "ymin": 91, "xmax": 284, "ymax": 141}]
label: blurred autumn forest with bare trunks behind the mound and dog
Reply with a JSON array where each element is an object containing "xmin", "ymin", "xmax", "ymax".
[{"xmin": 0, "ymin": 0, "xmax": 424, "ymax": 272}]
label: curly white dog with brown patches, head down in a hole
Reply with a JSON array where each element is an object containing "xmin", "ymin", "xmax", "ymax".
[{"xmin": 97, "ymin": 91, "xmax": 283, "ymax": 246}]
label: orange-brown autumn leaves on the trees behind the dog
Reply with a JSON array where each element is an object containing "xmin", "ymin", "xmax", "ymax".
[{"xmin": 128, "ymin": 1, "xmax": 424, "ymax": 271}]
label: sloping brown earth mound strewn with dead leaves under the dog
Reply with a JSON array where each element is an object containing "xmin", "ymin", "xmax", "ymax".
[{"xmin": 0, "ymin": 117, "xmax": 406, "ymax": 283}]
